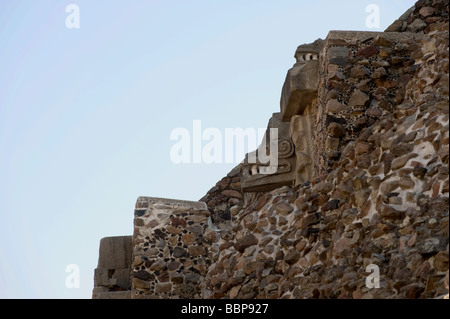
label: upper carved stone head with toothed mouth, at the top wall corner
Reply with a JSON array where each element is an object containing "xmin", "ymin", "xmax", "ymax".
[{"xmin": 280, "ymin": 39, "xmax": 323, "ymax": 122}]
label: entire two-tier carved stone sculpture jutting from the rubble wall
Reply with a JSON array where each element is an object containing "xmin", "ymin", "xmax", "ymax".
[{"xmin": 241, "ymin": 39, "xmax": 323, "ymax": 192}]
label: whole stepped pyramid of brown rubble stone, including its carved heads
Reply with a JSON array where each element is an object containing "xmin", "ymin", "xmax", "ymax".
[{"xmin": 93, "ymin": 0, "xmax": 449, "ymax": 299}]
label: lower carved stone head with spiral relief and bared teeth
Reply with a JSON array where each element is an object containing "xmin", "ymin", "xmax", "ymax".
[{"xmin": 241, "ymin": 113, "xmax": 295, "ymax": 192}]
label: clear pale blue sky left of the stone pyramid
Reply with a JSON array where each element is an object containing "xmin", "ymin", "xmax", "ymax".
[{"xmin": 0, "ymin": 0, "xmax": 414, "ymax": 298}]
